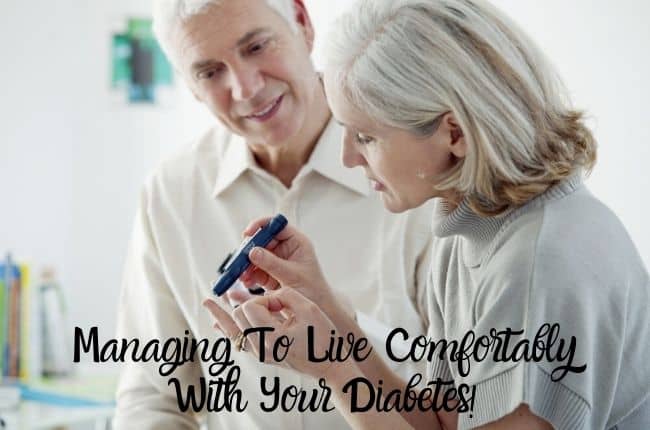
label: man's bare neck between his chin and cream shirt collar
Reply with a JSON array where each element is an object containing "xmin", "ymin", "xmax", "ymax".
[{"xmin": 250, "ymin": 83, "xmax": 331, "ymax": 188}]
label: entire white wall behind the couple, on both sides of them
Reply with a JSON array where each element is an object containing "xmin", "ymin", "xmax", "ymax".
[{"xmin": 0, "ymin": 0, "xmax": 650, "ymax": 352}]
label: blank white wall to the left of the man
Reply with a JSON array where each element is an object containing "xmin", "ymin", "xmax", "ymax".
[{"xmin": 0, "ymin": 0, "xmax": 209, "ymax": 346}]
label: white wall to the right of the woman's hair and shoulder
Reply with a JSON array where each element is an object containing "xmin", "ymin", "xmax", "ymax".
[{"xmin": 494, "ymin": 0, "xmax": 650, "ymax": 267}]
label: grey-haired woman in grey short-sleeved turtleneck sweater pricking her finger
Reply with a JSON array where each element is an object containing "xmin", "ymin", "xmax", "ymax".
[{"xmin": 201, "ymin": 0, "xmax": 650, "ymax": 430}]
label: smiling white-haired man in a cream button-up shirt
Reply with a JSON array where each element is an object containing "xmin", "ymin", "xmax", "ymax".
[{"xmin": 115, "ymin": 0, "xmax": 430, "ymax": 429}]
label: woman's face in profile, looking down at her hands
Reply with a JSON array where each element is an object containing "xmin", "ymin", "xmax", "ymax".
[{"xmin": 324, "ymin": 73, "xmax": 465, "ymax": 212}]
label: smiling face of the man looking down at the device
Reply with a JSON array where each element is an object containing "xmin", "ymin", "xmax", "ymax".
[{"xmin": 174, "ymin": 0, "xmax": 319, "ymax": 146}]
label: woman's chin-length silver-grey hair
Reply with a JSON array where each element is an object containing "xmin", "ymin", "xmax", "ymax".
[{"xmin": 326, "ymin": 0, "xmax": 596, "ymax": 215}]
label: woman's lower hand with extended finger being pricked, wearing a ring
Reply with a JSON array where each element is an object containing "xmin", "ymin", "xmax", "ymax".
[{"xmin": 203, "ymin": 288, "xmax": 340, "ymax": 380}]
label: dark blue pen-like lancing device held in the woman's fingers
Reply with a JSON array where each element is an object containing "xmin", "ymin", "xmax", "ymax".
[{"xmin": 212, "ymin": 214, "xmax": 287, "ymax": 296}]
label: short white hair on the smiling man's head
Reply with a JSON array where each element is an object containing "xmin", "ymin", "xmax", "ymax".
[{"xmin": 153, "ymin": 0, "xmax": 298, "ymax": 68}]
